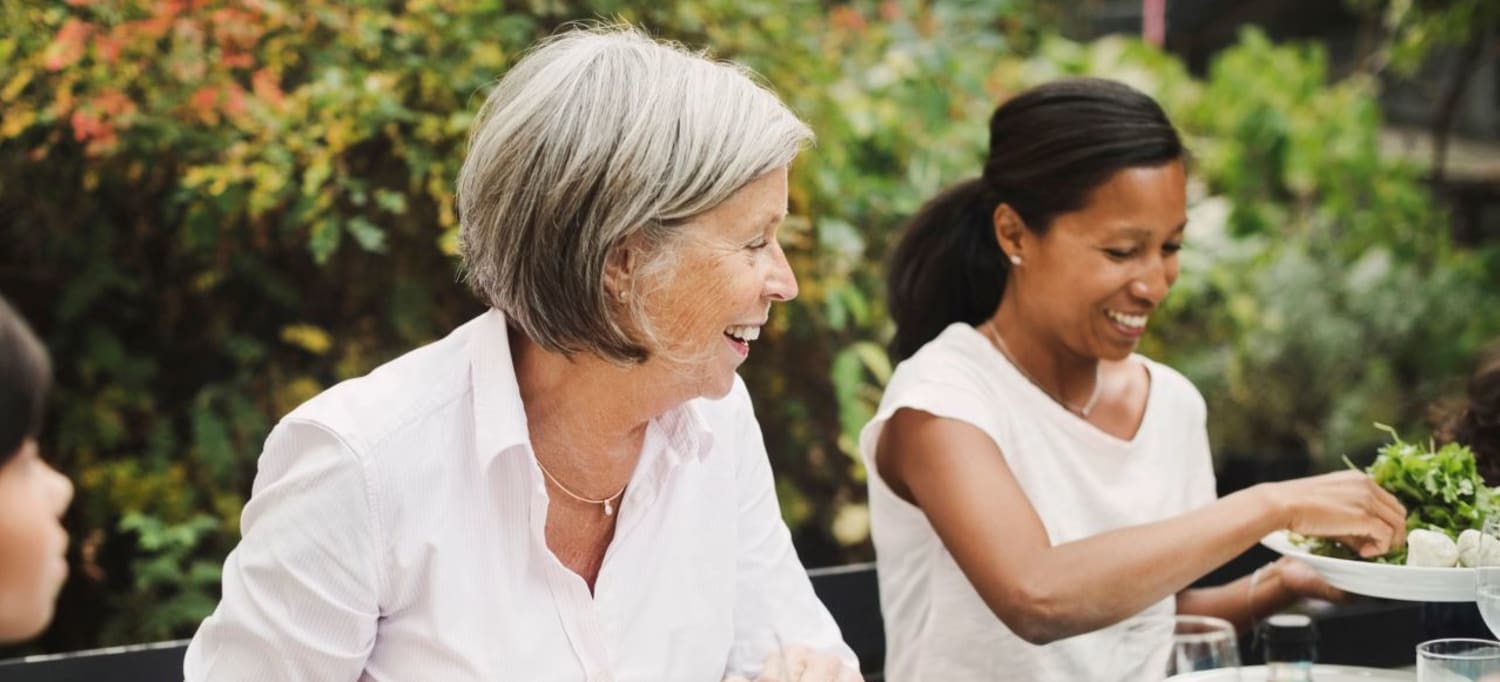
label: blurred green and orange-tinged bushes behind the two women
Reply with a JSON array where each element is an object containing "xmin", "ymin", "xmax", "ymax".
[{"xmin": 0, "ymin": 0, "xmax": 1500, "ymax": 651}]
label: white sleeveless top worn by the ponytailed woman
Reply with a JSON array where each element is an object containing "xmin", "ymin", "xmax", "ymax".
[{"xmin": 860, "ymin": 324, "xmax": 1215, "ymax": 682}]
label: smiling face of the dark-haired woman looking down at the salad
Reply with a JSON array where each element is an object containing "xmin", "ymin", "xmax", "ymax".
[{"xmin": 1002, "ymin": 160, "xmax": 1187, "ymax": 360}]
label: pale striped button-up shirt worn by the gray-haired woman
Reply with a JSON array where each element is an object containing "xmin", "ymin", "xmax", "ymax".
[{"xmin": 183, "ymin": 310, "xmax": 857, "ymax": 682}]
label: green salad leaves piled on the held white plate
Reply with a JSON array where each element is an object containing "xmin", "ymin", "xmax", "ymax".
[{"xmin": 1299, "ymin": 424, "xmax": 1500, "ymax": 564}]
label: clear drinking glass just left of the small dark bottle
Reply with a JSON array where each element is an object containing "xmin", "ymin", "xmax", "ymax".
[{"xmin": 1116, "ymin": 615, "xmax": 1239, "ymax": 681}]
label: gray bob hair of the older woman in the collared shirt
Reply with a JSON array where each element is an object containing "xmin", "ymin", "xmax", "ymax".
[{"xmin": 458, "ymin": 25, "xmax": 813, "ymax": 364}]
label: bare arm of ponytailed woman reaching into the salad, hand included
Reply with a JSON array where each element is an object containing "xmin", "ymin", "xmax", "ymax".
[{"xmin": 876, "ymin": 409, "xmax": 1406, "ymax": 643}]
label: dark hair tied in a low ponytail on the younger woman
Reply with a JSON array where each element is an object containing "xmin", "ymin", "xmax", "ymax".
[{"xmin": 887, "ymin": 78, "xmax": 1185, "ymax": 361}]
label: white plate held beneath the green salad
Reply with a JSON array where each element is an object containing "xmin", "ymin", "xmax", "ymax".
[{"xmin": 1260, "ymin": 531, "xmax": 1475, "ymax": 601}]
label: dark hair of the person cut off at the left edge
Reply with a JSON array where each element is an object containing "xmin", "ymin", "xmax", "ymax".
[{"xmin": 0, "ymin": 297, "xmax": 53, "ymax": 466}]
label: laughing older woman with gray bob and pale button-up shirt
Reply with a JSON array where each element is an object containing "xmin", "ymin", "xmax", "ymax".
[{"xmin": 185, "ymin": 27, "xmax": 858, "ymax": 682}]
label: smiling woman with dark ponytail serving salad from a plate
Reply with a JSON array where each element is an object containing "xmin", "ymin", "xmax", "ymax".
[{"xmin": 860, "ymin": 79, "xmax": 1406, "ymax": 682}]
